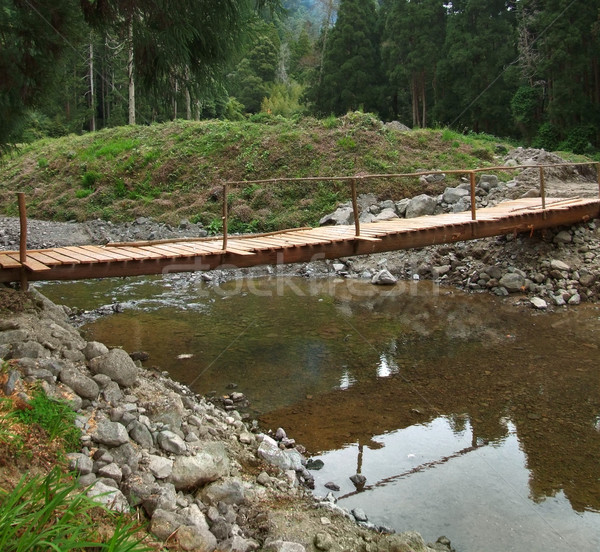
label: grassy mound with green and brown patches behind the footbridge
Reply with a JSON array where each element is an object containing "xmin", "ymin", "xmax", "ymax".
[{"xmin": 0, "ymin": 113, "xmax": 510, "ymax": 232}]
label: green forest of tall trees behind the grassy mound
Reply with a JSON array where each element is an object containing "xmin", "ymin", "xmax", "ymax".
[{"xmin": 0, "ymin": 0, "xmax": 600, "ymax": 153}]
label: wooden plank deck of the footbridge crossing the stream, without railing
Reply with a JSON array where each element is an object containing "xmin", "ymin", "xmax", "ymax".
[{"xmin": 0, "ymin": 198, "xmax": 600, "ymax": 282}]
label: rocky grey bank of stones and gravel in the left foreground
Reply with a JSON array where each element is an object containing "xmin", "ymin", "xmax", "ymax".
[{"xmin": 0, "ymin": 287, "xmax": 451, "ymax": 552}]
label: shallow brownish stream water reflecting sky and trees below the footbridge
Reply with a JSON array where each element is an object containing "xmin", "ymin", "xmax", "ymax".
[{"xmin": 42, "ymin": 276, "xmax": 600, "ymax": 552}]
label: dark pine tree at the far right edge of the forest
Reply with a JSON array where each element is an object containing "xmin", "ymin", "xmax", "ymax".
[{"xmin": 513, "ymin": 0, "xmax": 600, "ymax": 152}]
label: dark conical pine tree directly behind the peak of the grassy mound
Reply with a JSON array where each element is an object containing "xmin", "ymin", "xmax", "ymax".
[{"xmin": 309, "ymin": 0, "xmax": 381, "ymax": 115}]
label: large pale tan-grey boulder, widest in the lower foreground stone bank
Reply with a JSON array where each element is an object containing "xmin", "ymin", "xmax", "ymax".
[{"xmin": 169, "ymin": 442, "xmax": 229, "ymax": 490}]
